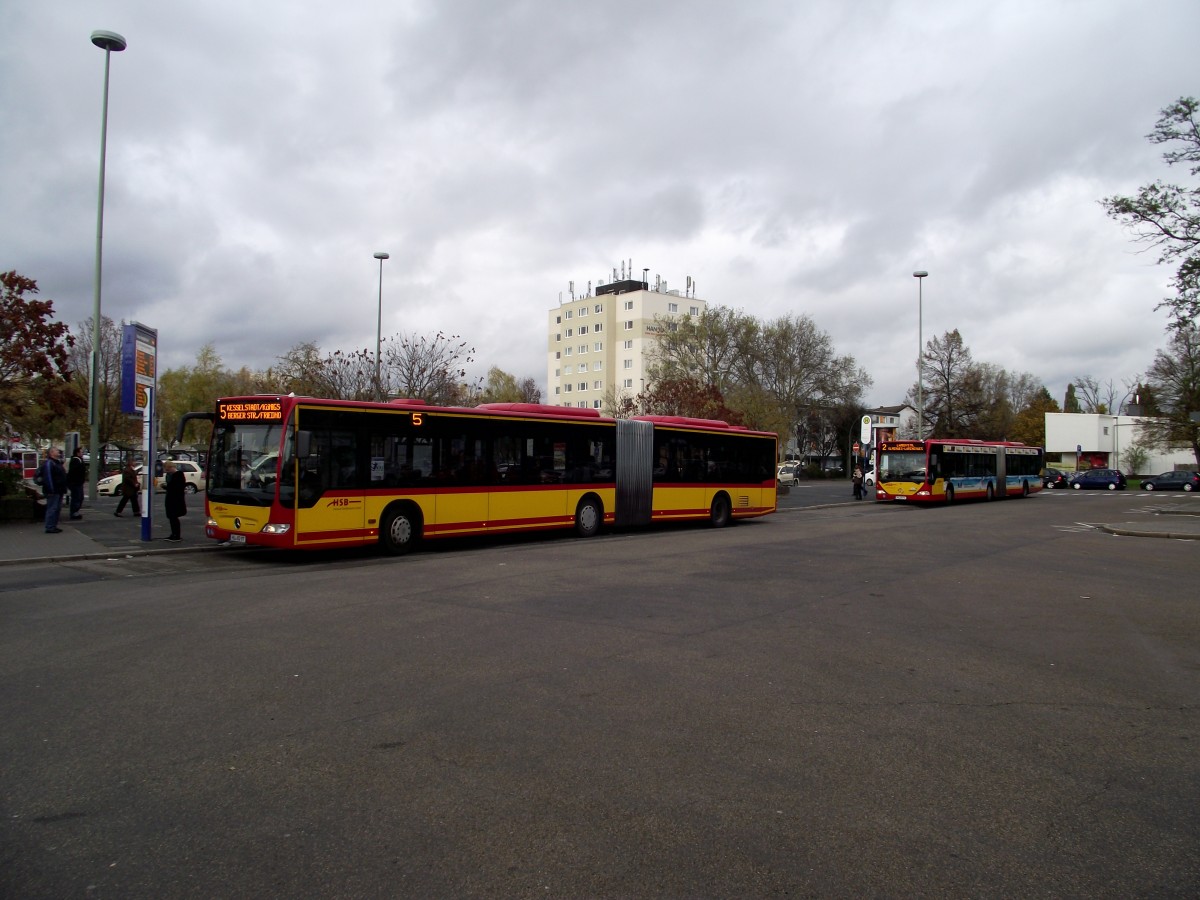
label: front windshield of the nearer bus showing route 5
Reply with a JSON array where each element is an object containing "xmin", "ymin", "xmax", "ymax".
[{"xmin": 209, "ymin": 422, "xmax": 283, "ymax": 506}]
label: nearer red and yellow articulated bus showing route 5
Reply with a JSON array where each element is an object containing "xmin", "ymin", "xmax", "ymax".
[{"xmin": 180, "ymin": 396, "xmax": 778, "ymax": 553}]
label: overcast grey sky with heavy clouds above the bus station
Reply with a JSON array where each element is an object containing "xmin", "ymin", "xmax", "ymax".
[{"xmin": 0, "ymin": 0, "xmax": 1200, "ymax": 403}]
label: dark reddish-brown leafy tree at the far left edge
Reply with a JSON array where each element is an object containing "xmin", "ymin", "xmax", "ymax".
[{"xmin": 0, "ymin": 271, "xmax": 82, "ymax": 438}]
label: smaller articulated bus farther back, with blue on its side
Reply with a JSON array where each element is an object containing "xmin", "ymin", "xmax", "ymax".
[{"xmin": 875, "ymin": 438, "xmax": 1044, "ymax": 503}]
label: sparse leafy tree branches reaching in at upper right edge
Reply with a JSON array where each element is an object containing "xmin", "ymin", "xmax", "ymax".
[{"xmin": 1100, "ymin": 97, "xmax": 1200, "ymax": 328}]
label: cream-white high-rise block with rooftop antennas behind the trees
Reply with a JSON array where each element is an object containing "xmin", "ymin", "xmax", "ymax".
[{"xmin": 545, "ymin": 280, "xmax": 707, "ymax": 413}]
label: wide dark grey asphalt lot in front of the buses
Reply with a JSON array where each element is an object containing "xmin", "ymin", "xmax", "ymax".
[{"xmin": 0, "ymin": 494, "xmax": 1200, "ymax": 898}]
